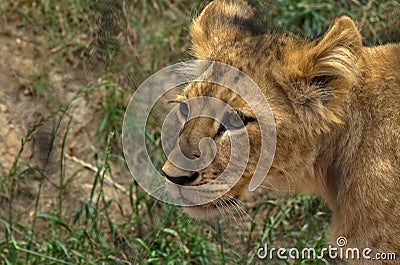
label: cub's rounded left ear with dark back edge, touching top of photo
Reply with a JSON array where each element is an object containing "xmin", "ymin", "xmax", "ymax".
[{"xmin": 190, "ymin": 0, "xmax": 257, "ymax": 59}]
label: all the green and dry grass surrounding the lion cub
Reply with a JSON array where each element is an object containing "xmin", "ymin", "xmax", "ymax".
[{"xmin": 0, "ymin": 0, "xmax": 400, "ymax": 264}]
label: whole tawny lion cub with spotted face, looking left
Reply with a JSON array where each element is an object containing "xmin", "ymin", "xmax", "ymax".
[{"xmin": 163, "ymin": 0, "xmax": 400, "ymax": 264}]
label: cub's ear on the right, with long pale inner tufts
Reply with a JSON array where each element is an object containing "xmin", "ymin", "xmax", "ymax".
[{"xmin": 284, "ymin": 16, "xmax": 362, "ymax": 132}]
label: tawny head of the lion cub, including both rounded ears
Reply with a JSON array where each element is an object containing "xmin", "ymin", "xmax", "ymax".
[{"xmin": 163, "ymin": 0, "xmax": 362, "ymax": 218}]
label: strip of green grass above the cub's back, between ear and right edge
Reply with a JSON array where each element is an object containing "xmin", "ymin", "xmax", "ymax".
[{"xmin": 249, "ymin": 0, "xmax": 400, "ymax": 45}]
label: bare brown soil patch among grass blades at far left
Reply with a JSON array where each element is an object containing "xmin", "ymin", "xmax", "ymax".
[{"xmin": 0, "ymin": 25, "xmax": 130, "ymax": 232}]
